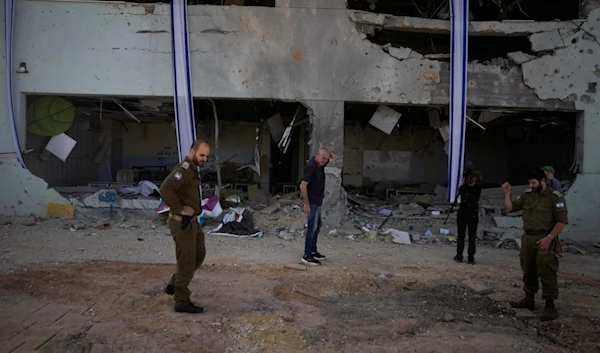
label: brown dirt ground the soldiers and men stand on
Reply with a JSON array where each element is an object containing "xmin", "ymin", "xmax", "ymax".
[{"xmin": 0, "ymin": 220, "xmax": 600, "ymax": 353}]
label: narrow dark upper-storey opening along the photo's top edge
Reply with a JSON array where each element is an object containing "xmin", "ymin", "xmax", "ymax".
[{"xmin": 348, "ymin": 0, "xmax": 579, "ymax": 21}]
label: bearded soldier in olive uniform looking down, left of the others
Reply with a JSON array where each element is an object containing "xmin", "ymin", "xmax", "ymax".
[{"xmin": 160, "ymin": 140, "xmax": 210, "ymax": 314}]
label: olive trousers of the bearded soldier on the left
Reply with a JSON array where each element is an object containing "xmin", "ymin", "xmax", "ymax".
[{"xmin": 167, "ymin": 217, "xmax": 206, "ymax": 306}]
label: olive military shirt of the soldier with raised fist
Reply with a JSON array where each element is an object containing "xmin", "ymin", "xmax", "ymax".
[{"xmin": 512, "ymin": 188, "xmax": 569, "ymax": 235}]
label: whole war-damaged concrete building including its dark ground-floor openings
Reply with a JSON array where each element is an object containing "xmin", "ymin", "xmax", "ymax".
[{"xmin": 0, "ymin": 0, "xmax": 600, "ymax": 240}]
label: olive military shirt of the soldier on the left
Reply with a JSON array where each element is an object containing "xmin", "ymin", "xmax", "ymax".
[{"xmin": 160, "ymin": 157, "xmax": 202, "ymax": 215}]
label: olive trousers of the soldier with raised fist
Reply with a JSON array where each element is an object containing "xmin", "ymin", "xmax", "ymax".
[{"xmin": 520, "ymin": 234, "xmax": 558, "ymax": 300}]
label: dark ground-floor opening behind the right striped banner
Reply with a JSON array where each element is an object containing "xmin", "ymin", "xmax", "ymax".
[{"xmin": 343, "ymin": 103, "xmax": 576, "ymax": 198}]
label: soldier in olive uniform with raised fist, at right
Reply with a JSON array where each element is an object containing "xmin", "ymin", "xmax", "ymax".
[{"xmin": 502, "ymin": 169, "xmax": 568, "ymax": 321}]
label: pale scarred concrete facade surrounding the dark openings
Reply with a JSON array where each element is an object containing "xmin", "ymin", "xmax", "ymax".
[{"xmin": 0, "ymin": 0, "xmax": 600, "ymax": 240}]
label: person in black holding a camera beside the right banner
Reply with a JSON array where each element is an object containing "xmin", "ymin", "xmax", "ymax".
[{"xmin": 454, "ymin": 170, "xmax": 481, "ymax": 265}]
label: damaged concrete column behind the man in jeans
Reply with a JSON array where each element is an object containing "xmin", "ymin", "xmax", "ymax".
[{"xmin": 305, "ymin": 101, "xmax": 348, "ymax": 228}]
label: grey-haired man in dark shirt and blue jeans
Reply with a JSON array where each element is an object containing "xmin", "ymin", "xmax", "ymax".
[{"xmin": 300, "ymin": 147, "xmax": 335, "ymax": 265}]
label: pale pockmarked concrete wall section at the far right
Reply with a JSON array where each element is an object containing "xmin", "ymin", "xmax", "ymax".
[{"xmin": 522, "ymin": 8, "xmax": 600, "ymax": 240}]
